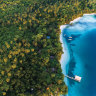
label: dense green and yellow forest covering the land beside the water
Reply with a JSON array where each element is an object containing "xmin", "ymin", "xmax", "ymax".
[{"xmin": 0, "ymin": 0, "xmax": 96, "ymax": 96}]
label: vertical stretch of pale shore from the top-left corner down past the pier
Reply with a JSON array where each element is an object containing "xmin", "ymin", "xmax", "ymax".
[{"xmin": 60, "ymin": 25, "xmax": 70, "ymax": 96}]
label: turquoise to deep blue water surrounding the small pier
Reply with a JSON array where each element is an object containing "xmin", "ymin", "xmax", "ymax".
[{"xmin": 62, "ymin": 15, "xmax": 96, "ymax": 96}]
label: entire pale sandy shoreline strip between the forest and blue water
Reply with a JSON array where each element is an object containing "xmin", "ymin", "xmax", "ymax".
[{"xmin": 60, "ymin": 13, "xmax": 96, "ymax": 96}]
